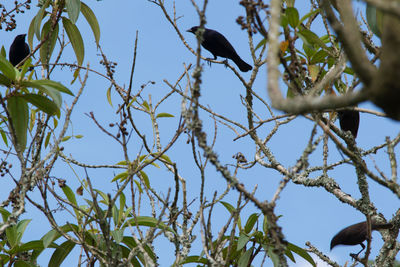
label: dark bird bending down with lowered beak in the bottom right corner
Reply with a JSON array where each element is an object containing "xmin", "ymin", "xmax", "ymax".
[{"xmin": 331, "ymin": 222, "xmax": 393, "ymax": 257}]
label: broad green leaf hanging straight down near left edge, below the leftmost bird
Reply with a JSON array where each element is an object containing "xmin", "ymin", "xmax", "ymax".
[{"xmin": 7, "ymin": 96, "xmax": 29, "ymax": 151}]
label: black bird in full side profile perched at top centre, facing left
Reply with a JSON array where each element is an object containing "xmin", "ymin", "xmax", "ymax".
[{"xmin": 187, "ymin": 26, "xmax": 252, "ymax": 72}]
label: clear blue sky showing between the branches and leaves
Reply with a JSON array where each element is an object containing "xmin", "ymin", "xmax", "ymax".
[{"xmin": 0, "ymin": 0, "xmax": 400, "ymax": 266}]
